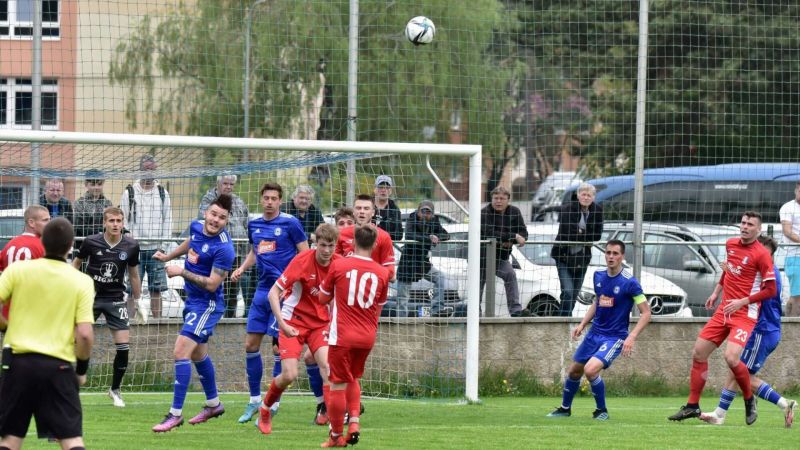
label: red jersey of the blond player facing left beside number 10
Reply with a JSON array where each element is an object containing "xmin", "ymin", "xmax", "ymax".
[{"xmin": 275, "ymin": 249, "xmax": 341, "ymax": 329}]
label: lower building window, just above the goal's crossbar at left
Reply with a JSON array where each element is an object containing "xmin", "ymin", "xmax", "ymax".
[{"xmin": 0, "ymin": 78, "xmax": 58, "ymax": 130}]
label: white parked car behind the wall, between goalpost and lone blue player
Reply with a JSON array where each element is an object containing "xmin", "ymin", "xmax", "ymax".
[{"xmin": 431, "ymin": 224, "xmax": 691, "ymax": 317}]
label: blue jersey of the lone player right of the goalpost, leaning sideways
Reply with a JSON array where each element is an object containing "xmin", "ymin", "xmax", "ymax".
[{"xmin": 591, "ymin": 269, "xmax": 642, "ymax": 339}]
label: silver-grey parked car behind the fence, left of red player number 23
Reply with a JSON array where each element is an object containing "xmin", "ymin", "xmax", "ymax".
[{"xmin": 602, "ymin": 222, "xmax": 789, "ymax": 317}]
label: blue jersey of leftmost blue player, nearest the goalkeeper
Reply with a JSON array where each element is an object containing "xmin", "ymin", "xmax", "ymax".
[{"xmin": 183, "ymin": 220, "xmax": 236, "ymax": 309}]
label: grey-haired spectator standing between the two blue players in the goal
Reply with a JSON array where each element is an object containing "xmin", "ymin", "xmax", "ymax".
[{"xmin": 197, "ymin": 175, "xmax": 255, "ymax": 318}]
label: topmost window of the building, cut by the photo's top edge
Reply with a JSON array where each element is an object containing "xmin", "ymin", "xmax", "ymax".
[{"xmin": 0, "ymin": 0, "xmax": 60, "ymax": 38}]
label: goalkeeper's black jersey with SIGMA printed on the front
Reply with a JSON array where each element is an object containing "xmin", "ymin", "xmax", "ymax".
[{"xmin": 78, "ymin": 233, "xmax": 139, "ymax": 302}]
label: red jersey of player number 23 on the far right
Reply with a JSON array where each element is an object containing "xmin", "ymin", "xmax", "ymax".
[{"xmin": 716, "ymin": 237, "xmax": 775, "ymax": 320}]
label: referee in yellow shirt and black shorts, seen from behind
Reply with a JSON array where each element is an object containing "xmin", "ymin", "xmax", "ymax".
[{"xmin": 0, "ymin": 217, "xmax": 94, "ymax": 450}]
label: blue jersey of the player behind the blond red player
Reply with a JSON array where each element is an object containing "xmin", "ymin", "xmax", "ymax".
[{"xmin": 247, "ymin": 213, "xmax": 308, "ymax": 290}]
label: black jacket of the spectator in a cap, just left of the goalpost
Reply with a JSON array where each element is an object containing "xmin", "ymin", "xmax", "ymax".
[{"xmin": 397, "ymin": 211, "xmax": 450, "ymax": 283}]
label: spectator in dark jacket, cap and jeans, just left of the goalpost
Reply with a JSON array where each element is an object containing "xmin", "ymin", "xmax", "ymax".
[{"xmin": 397, "ymin": 200, "xmax": 453, "ymax": 317}]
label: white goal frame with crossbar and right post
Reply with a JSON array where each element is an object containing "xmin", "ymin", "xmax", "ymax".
[{"xmin": 0, "ymin": 130, "xmax": 482, "ymax": 402}]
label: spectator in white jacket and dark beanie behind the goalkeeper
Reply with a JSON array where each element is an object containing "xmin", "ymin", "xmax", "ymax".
[{"xmin": 119, "ymin": 155, "xmax": 172, "ymax": 319}]
